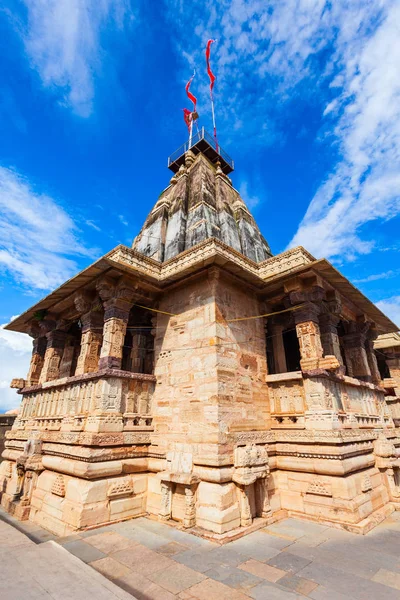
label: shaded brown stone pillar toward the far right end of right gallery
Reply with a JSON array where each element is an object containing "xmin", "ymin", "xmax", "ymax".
[{"xmin": 343, "ymin": 321, "xmax": 371, "ymax": 381}]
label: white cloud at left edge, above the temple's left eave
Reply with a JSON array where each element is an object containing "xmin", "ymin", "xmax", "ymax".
[{"xmin": 0, "ymin": 167, "xmax": 92, "ymax": 290}]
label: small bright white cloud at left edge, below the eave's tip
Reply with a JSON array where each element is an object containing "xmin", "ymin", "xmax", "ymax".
[{"xmin": 0, "ymin": 316, "xmax": 32, "ymax": 413}]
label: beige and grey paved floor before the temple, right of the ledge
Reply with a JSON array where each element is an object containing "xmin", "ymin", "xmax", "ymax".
[{"xmin": 0, "ymin": 513, "xmax": 400, "ymax": 600}]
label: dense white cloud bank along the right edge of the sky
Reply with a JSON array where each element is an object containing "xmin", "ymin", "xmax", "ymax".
[{"xmin": 290, "ymin": 1, "xmax": 400, "ymax": 259}]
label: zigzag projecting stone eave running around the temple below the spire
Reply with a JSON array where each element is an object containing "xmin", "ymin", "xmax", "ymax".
[{"xmin": 5, "ymin": 238, "xmax": 398, "ymax": 333}]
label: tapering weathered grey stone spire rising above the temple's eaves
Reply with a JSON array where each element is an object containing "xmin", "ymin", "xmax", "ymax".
[{"xmin": 132, "ymin": 149, "xmax": 272, "ymax": 263}]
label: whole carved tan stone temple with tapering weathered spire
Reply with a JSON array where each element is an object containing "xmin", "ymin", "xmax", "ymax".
[{"xmin": 0, "ymin": 131, "xmax": 400, "ymax": 539}]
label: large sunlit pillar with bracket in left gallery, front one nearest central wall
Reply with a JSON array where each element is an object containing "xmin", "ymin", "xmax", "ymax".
[{"xmin": 97, "ymin": 280, "xmax": 135, "ymax": 369}]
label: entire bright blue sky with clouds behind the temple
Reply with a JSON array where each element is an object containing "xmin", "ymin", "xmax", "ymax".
[{"xmin": 0, "ymin": 0, "xmax": 400, "ymax": 408}]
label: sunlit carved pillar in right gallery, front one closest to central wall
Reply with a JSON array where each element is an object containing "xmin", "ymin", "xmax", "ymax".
[{"xmin": 293, "ymin": 302, "xmax": 323, "ymax": 370}]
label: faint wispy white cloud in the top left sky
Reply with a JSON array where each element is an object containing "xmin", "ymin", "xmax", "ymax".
[{"xmin": 20, "ymin": 0, "xmax": 133, "ymax": 117}]
